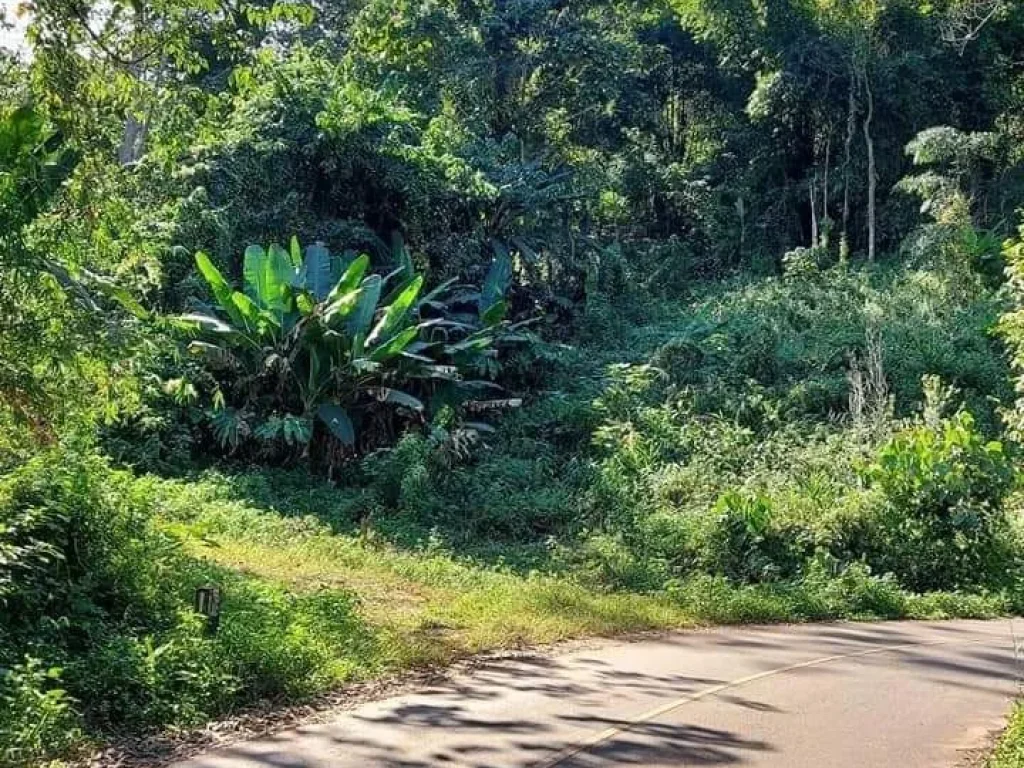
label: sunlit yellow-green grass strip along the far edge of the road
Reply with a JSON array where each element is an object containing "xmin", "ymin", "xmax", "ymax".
[{"xmin": 148, "ymin": 468, "xmax": 1008, "ymax": 676}]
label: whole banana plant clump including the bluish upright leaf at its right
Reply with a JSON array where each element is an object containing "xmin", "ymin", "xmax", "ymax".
[{"xmin": 178, "ymin": 240, "xmax": 511, "ymax": 466}]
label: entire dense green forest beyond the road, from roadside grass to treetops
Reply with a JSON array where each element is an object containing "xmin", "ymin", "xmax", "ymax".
[{"xmin": 0, "ymin": 0, "xmax": 1024, "ymax": 766}]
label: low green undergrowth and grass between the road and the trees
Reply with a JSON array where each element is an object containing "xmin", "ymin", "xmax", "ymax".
[{"xmin": 0, "ymin": 268, "xmax": 1022, "ymax": 765}]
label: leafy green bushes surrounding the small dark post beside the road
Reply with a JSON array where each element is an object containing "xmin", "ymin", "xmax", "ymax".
[{"xmin": 0, "ymin": 450, "xmax": 373, "ymax": 764}]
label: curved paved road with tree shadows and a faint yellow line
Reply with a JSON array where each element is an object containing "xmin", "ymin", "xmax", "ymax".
[{"xmin": 176, "ymin": 621, "xmax": 1024, "ymax": 768}]
